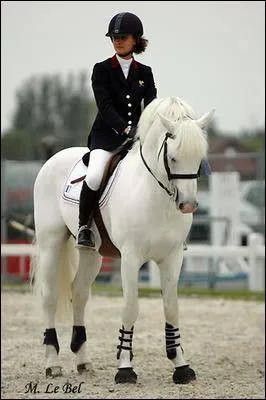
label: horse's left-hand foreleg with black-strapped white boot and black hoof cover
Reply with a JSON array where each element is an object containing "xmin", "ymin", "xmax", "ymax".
[{"xmin": 115, "ymin": 256, "xmax": 139, "ymax": 383}]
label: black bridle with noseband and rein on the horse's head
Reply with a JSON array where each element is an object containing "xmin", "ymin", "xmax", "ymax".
[{"xmin": 139, "ymin": 132, "xmax": 201, "ymax": 200}]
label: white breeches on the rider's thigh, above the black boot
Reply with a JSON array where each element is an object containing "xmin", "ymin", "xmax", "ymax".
[{"xmin": 85, "ymin": 149, "xmax": 114, "ymax": 190}]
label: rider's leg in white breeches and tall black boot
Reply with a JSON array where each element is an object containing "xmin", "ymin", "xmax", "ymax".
[{"xmin": 77, "ymin": 149, "xmax": 113, "ymax": 248}]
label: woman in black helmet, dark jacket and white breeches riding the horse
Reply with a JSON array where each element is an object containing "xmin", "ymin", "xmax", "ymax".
[{"xmin": 76, "ymin": 12, "xmax": 157, "ymax": 249}]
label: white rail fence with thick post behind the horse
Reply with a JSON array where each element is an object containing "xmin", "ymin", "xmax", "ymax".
[{"xmin": 1, "ymin": 233, "xmax": 265, "ymax": 291}]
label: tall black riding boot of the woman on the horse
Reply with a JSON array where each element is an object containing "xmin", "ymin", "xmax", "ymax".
[{"xmin": 76, "ymin": 182, "xmax": 98, "ymax": 249}]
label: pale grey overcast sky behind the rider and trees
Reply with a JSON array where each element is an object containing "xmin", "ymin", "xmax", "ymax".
[{"xmin": 1, "ymin": 1, "xmax": 265, "ymax": 134}]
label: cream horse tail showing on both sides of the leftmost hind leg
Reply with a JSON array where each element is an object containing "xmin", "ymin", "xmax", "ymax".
[{"xmin": 30, "ymin": 237, "xmax": 78, "ymax": 322}]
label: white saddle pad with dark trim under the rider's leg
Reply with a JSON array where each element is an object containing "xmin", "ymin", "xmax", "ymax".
[{"xmin": 62, "ymin": 159, "xmax": 123, "ymax": 208}]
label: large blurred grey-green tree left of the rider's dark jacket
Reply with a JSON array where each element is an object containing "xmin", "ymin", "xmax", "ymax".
[{"xmin": 1, "ymin": 71, "xmax": 96, "ymax": 160}]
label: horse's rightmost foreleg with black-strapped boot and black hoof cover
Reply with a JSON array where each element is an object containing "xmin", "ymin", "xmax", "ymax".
[{"xmin": 158, "ymin": 248, "xmax": 196, "ymax": 383}]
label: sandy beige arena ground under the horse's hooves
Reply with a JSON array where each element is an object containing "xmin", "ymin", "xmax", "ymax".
[{"xmin": 1, "ymin": 291, "xmax": 265, "ymax": 399}]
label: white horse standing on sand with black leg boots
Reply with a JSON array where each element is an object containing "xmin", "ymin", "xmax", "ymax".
[{"xmin": 32, "ymin": 98, "xmax": 213, "ymax": 383}]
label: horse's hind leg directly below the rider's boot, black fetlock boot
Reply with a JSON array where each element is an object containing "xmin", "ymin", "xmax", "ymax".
[{"xmin": 70, "ymin": 249, "xmax": 102, "ymax": 373}]
